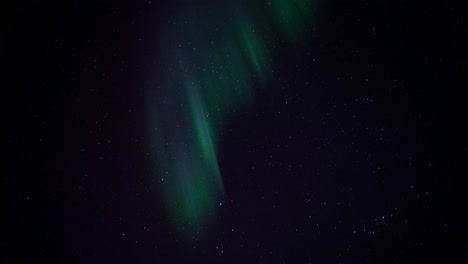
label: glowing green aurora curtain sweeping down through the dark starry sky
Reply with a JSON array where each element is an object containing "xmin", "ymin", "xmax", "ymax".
[{"xmin": 148, "ymin": 0, "xmax": 315, "ymax": 235}]
